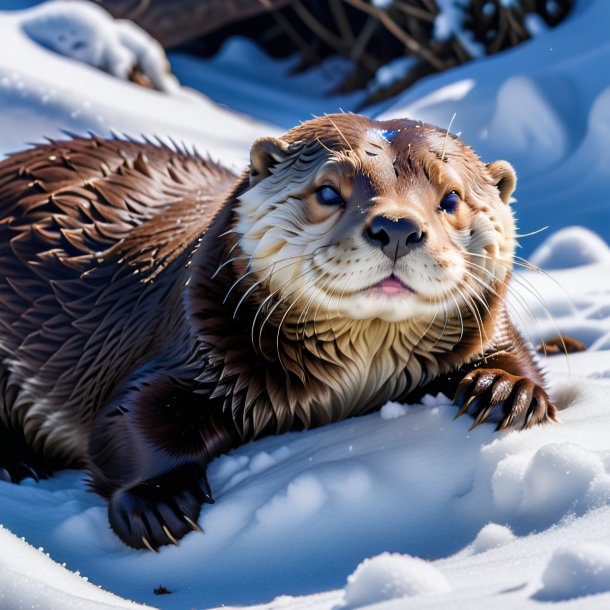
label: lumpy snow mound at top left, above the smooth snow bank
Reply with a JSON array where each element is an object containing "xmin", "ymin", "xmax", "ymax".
[{"xmin": 21, "ymin": 1, "xmax": 179, "ymax": 91}]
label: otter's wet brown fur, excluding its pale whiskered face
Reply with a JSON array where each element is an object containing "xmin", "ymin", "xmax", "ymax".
[{"xmin": 0, "ymin": 115, "xmax": 554, "ymax": 547}]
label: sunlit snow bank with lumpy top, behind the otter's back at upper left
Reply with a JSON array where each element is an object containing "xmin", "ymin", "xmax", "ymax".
[{"xmin": 0, "ymin": 2, "xmax": 278, "ymax": 165}]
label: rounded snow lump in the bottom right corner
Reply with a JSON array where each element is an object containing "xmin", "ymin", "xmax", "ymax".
[{"xmin": 534, "ymin": 542, "xmax": 610, "ymax": 602}]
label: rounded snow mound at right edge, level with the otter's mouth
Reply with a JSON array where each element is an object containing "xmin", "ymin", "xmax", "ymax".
[{"xmin": 530, "ymin": 227, "xmax": 610, "ymax": 269}]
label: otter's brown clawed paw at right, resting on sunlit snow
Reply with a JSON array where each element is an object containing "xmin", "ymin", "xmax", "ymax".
[{"xmin": 454, "ymin": 369, "xmax": 557, "ymax": 430}]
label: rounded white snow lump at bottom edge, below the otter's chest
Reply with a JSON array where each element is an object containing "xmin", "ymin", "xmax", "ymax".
[{"xmin": 337, "ymin": 553, "xmax": 451, "ymax": 610}]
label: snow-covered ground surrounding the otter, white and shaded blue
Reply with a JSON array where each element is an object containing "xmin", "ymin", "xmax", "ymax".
[{"xmin": 0, "ymin": 0, "xmax": 610, "ymax": 610}]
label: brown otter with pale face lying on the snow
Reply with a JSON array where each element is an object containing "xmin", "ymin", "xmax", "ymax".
[{"xmin": 0, "ymin": 114, "xmax": 556, "ymax": 550}]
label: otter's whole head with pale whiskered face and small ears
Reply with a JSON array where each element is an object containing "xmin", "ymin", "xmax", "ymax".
[{"xmin": 236, "ymin": 114, "xmax": 516, "ymax": 322}]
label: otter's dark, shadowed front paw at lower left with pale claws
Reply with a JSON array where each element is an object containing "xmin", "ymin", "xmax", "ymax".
[{"xmin": 108, "ymin": 471, "xmax": 214, "ymax": 551}]
